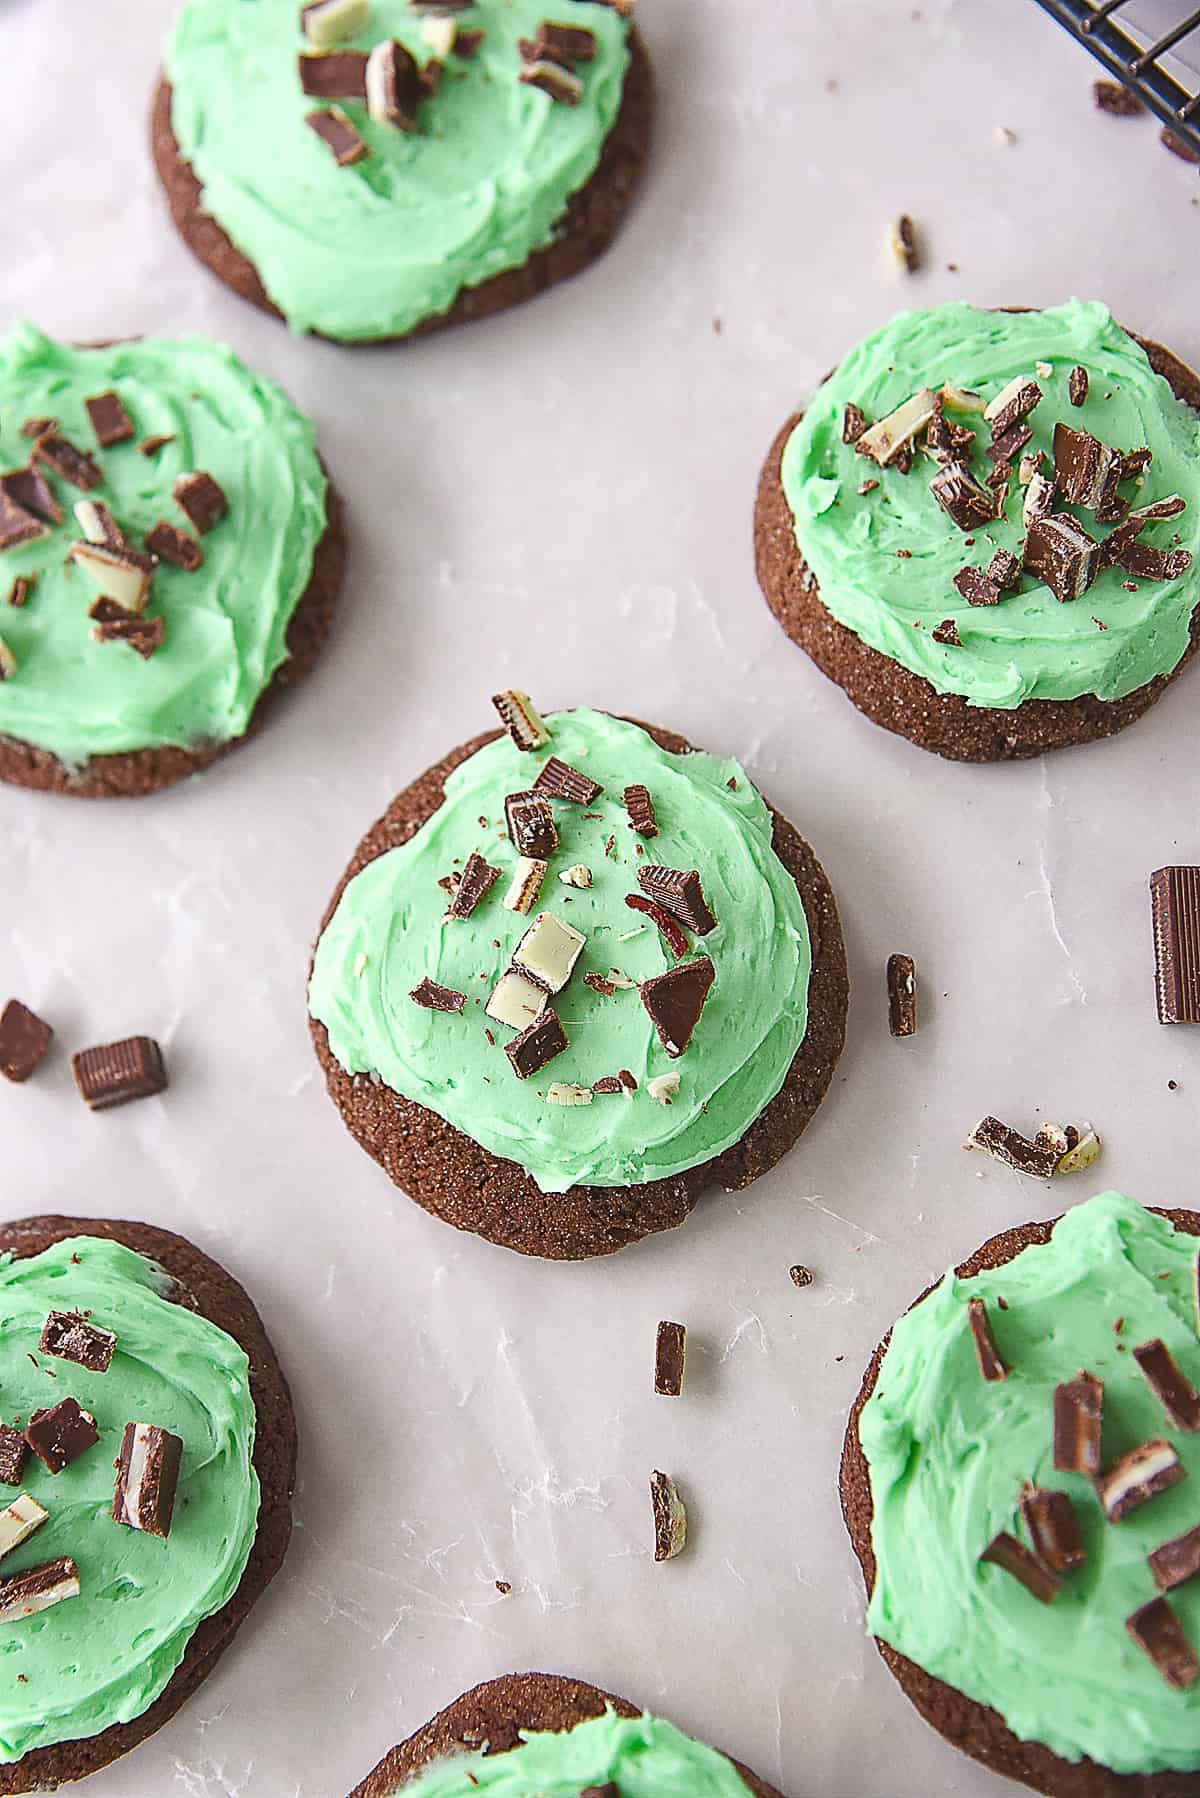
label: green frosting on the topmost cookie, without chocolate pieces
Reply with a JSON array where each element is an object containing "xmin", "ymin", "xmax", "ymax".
[{"xmin": 166, "ymin": 0, "xmax": 628, "ymax": 340}]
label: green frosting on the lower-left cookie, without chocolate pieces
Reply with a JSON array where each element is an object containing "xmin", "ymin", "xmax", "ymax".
[{"xmin": 0, "ymin": 1237, "xmax": 259, "ymax": 1762}]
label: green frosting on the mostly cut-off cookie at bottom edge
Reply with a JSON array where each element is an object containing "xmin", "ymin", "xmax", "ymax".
[{"xmin": 386, "ymin": 1710, "xmax": 747, "ymax": 1798}]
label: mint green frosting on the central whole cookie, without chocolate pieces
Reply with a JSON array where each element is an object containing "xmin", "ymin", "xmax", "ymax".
[{"xmin": 309, "ymin": 710, "xmax": 811, "ymax": 1192}]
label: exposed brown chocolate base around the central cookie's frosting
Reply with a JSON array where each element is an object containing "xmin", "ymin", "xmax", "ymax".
[{"xmin": 309, "ymin": 725, "xmax": 849, "ymax": 1260}]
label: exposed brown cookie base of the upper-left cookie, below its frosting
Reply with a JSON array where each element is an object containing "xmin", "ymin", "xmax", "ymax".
[{"xmin": 0, "ymin": 484, "xmax": 345, "ymax": 798}]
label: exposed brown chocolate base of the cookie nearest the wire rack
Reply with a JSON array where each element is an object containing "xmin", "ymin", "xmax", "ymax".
[{"xmin": 754, "ymin": 333, "xmax": 1200, "ymax": 762}]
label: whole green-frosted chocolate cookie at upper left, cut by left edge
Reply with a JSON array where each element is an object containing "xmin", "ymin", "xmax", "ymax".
[{"xmin": 0, "ymin": 325, "xmax": 344, "ymax": 798}]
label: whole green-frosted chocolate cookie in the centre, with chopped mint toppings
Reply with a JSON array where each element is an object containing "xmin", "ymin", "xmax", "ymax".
[{"xmin": 309, "ymin": 694, "xmax": 847, "ymax": 1259}]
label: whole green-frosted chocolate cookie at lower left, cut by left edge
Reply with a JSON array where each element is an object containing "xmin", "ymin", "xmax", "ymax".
[{"xmin": 0, "ymin": 1217, "xmax": 295, "ymax": 1793}]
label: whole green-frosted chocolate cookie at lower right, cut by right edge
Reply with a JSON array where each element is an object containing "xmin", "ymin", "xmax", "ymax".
[{"xmin": 842, "ymin": 1192, "xmax": 1200, "ymax": 1798}]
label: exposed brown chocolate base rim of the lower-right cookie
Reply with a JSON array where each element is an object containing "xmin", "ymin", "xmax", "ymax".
[{"xmin": 840, "ymin": 1210, "xmax": 1200, "ymax": 1798}]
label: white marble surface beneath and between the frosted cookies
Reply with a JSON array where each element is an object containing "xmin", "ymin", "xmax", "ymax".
[{"xmin": 0, "ymin": 0, "xmax": 1200, "ymax": 1798}]
